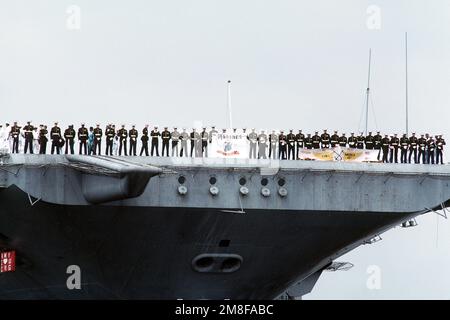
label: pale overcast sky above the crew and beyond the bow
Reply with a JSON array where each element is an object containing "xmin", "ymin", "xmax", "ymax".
[{"xmin": 0, "ymin": 0, "xmax": 450, "ymax": 299}]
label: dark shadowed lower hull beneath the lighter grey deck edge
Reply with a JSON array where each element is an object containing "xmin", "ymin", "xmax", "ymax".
[{"xmin": 0, "ymin": 187, "xmax": 418, "ymax": 299}]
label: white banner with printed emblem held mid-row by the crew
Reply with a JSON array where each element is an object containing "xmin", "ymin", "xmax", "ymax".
[{"xmin": 208, "ymin": 133, "xmax": 249, "ymax": 159}]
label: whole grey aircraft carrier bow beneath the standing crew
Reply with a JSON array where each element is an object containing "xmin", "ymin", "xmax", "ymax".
[{"xmin": 0, "ymin": 154, "xmax": 450, "ymax": 299}]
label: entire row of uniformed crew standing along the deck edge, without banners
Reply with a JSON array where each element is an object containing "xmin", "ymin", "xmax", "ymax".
[{"xmin": 0, "ymin": 122, "xmax": 446, "ymax": 164}]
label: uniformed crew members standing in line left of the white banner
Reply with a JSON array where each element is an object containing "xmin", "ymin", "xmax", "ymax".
[{"xmin": 0, "ymin": 122, "xmax": 217, "ymax": 157}]
